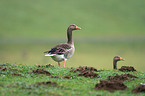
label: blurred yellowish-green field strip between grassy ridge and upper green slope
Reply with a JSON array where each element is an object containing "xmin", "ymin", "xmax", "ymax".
[{"xmin": 0, "ymin": 38, "xmax": 145, "ymax": 71}]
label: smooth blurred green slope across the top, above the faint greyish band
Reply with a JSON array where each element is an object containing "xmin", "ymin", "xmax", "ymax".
[{"xmin": 0, "ymin": 0, "xmax": 145, "ymax": 39}]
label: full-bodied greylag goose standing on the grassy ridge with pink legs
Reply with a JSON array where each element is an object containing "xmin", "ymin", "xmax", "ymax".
[{"xmin": 44, "ymin": 24, "xmax": 81, "ymax": 67}]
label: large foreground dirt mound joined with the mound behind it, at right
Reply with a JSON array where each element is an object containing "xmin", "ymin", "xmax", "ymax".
[{"xmin": 95, "ymin": 74, "xmax": 138, "ymax": 92}]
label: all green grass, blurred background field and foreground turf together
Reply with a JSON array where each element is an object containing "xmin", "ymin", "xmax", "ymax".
[{"xmin": 0, "ymin": 0, "xmax": 145, "ymax": 96}]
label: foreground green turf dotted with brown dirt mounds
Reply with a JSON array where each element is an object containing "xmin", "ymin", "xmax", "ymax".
[{"xmin": 0, "ymin": 64, "xmax": 145, "ymax": 96}]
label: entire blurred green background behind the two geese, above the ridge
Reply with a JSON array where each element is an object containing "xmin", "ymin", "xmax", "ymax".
[{"xmin": 0, "ymin": 0, "xmax": 145, "ymax": 71}]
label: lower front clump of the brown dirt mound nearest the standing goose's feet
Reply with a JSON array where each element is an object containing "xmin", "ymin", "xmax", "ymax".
[{"xmin": 77, "ymin": 70, "xmax": 99, "ymax": 78}]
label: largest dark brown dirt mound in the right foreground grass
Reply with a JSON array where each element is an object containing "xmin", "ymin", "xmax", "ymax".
[{"xmin": 95, "ymin": 80, "xmax": 127, "ymax": 92}]
